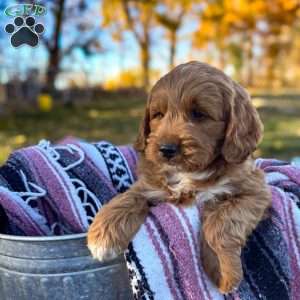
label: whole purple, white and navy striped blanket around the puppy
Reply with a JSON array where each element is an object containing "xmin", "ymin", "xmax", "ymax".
[{"xmin": 0, "ymin": 139, "xmax": 300, "ymax": 300}]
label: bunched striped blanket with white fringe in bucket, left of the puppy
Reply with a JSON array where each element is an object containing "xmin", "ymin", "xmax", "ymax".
[{"xmin": 0, "ymin": 138, "xmax": 137, "ymax": 236}]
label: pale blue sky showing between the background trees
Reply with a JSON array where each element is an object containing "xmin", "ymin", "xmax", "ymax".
[{"xmin": 0, "ymin": 0, "xmax": 201, "ymax": 87}]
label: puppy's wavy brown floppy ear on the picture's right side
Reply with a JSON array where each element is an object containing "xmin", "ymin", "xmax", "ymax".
[{"xmin": 222, "ymin": 82, "xmax": 263, "ymax": 163}]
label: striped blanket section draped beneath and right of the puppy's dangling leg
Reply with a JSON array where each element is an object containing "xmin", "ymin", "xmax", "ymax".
[{"xmin": 126, "ymin": 159, "xmax": 300, "ymax": 300}]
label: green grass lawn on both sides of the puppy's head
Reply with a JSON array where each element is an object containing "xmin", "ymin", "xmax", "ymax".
[{"xmin": 0, "ymin": 96, "xmax": 300, "ymax": 162}]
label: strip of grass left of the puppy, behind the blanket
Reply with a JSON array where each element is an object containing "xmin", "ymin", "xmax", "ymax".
[{"xmin": 0, "ymin": 97, "xmax": 145, "ymax": 162}]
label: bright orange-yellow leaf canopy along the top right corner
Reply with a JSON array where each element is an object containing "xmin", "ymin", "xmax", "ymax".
[{"xmin": 194, "ymin": 0, "xmax": 299, "ymax": 48}]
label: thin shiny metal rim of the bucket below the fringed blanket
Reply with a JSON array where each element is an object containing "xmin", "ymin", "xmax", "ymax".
[{"xmin": 0, "ymin": 233, "xmax": 87, "ymax": 242}]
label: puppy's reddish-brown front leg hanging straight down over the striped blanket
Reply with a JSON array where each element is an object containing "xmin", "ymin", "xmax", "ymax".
[{"xmin": 201, "ymin": 196, "xmax": 269, "ymax": 294}]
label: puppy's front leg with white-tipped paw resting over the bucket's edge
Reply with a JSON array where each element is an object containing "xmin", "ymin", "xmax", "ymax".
[{"xmin": 87, "ymin": 182, "xmax": 149, "ymax": 261}]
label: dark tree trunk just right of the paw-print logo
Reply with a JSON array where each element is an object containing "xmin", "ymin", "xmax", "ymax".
[{"xmin": 46, "ymin": 0, "xmax": 65, "ymax": 93}]
